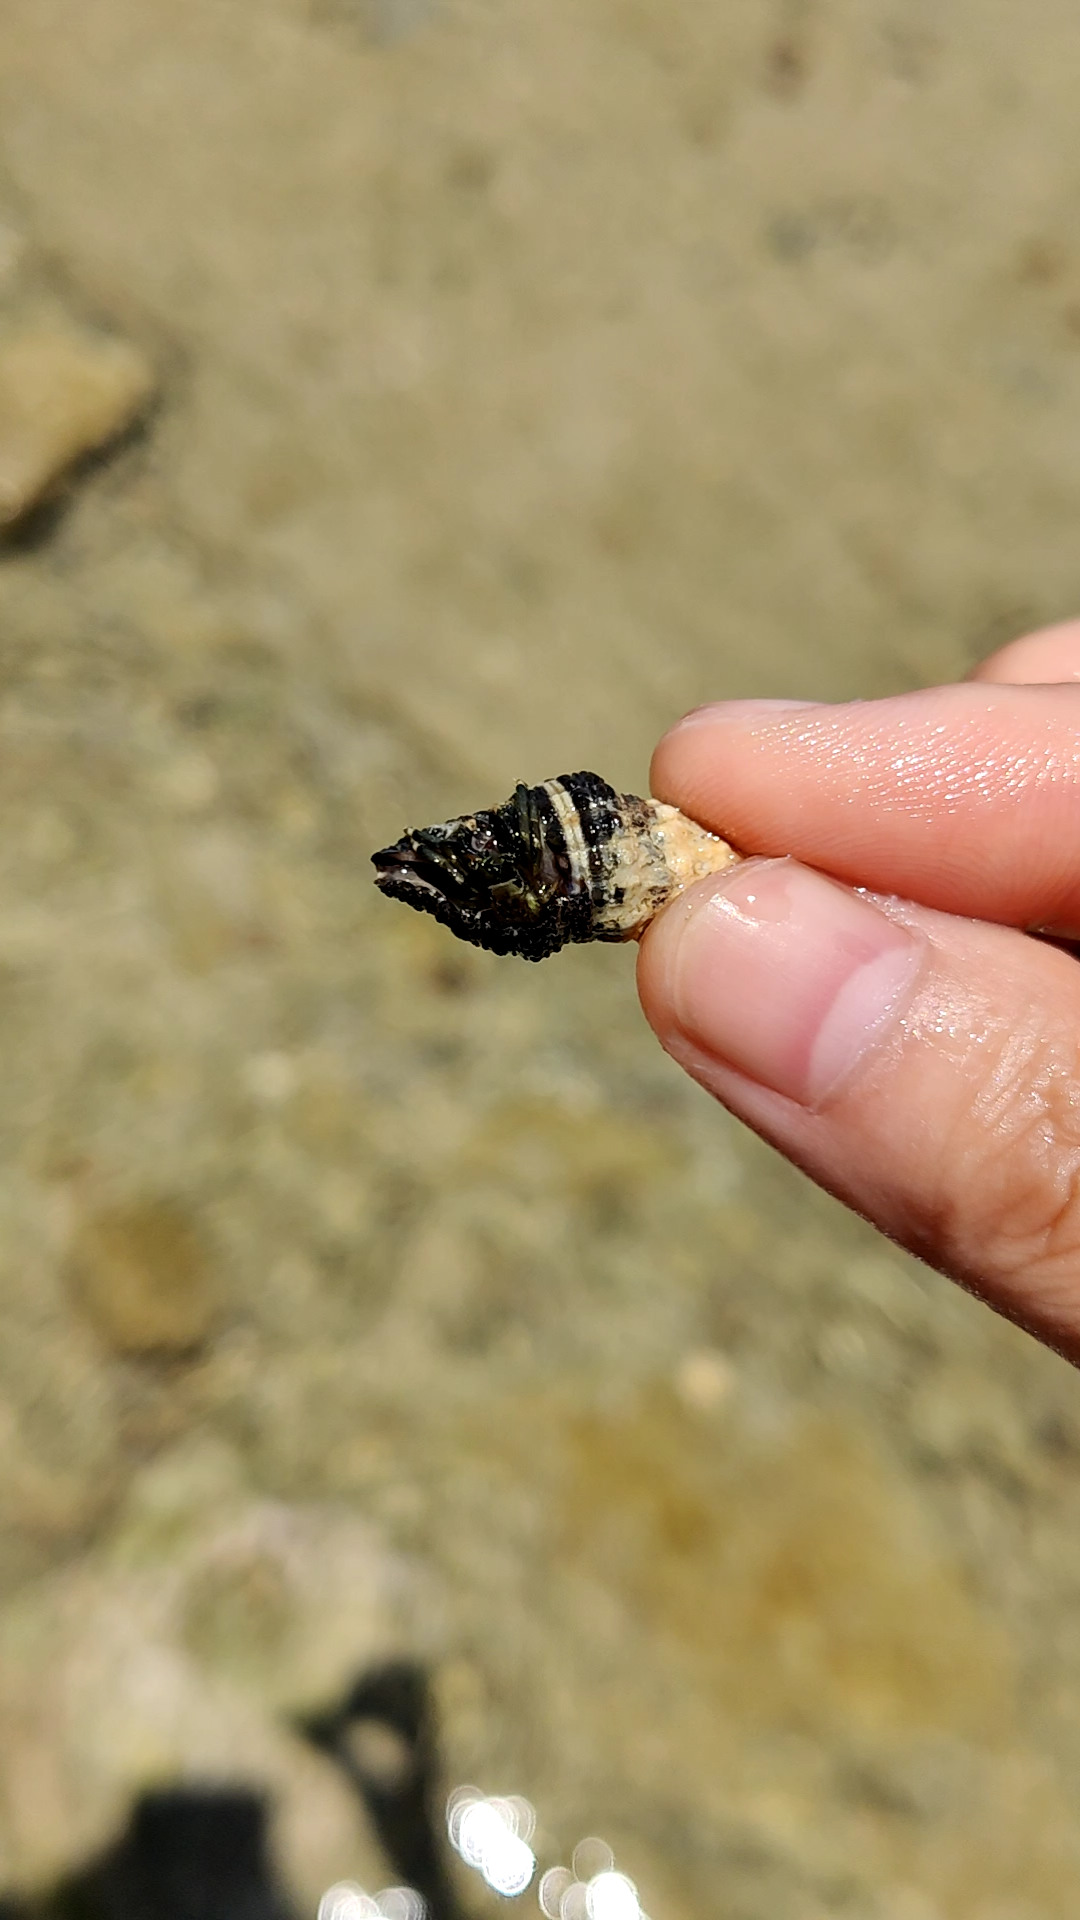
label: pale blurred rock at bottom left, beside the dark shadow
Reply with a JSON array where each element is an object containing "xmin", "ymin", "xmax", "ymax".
[{"xmin": 0, "ymin": 1440, "xmax": 405, "ymax": 1914}]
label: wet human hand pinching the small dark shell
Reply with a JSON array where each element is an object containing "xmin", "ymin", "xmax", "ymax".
[{"xmin": 638, "ymin": 622, "xmax": 1080, "ymax": 1361}]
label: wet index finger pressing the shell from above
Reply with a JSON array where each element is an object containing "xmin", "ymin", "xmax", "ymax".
[{"xmin": 651, "ymin": 682, "xmax": 1080, "ymax": 937}]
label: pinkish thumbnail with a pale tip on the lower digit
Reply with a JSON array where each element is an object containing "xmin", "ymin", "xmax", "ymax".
[{"xmin": 661, "ymin": 860, "xmax": 924, "ymax": 1108}]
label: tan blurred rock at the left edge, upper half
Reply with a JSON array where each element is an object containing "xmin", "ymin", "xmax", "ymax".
[{"xmin": 0, "ymin": 313, "xmax": 156, "ymax": 528}]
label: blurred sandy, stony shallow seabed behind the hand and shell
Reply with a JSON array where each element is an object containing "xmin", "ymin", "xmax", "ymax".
[{"xmin": 0, "ymin": 0, "xmax": 1080, "ymax": 1920}]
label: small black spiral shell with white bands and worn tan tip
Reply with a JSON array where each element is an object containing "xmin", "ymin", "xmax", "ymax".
[{"xmin": 371, "ymin": 774, "xmax": 740, "ymax": 960}]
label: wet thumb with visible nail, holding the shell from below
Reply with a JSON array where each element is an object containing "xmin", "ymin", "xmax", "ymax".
[{"xmin": 638, "ymin": 860, "xmax": 1080, "ymax": 1359}]
